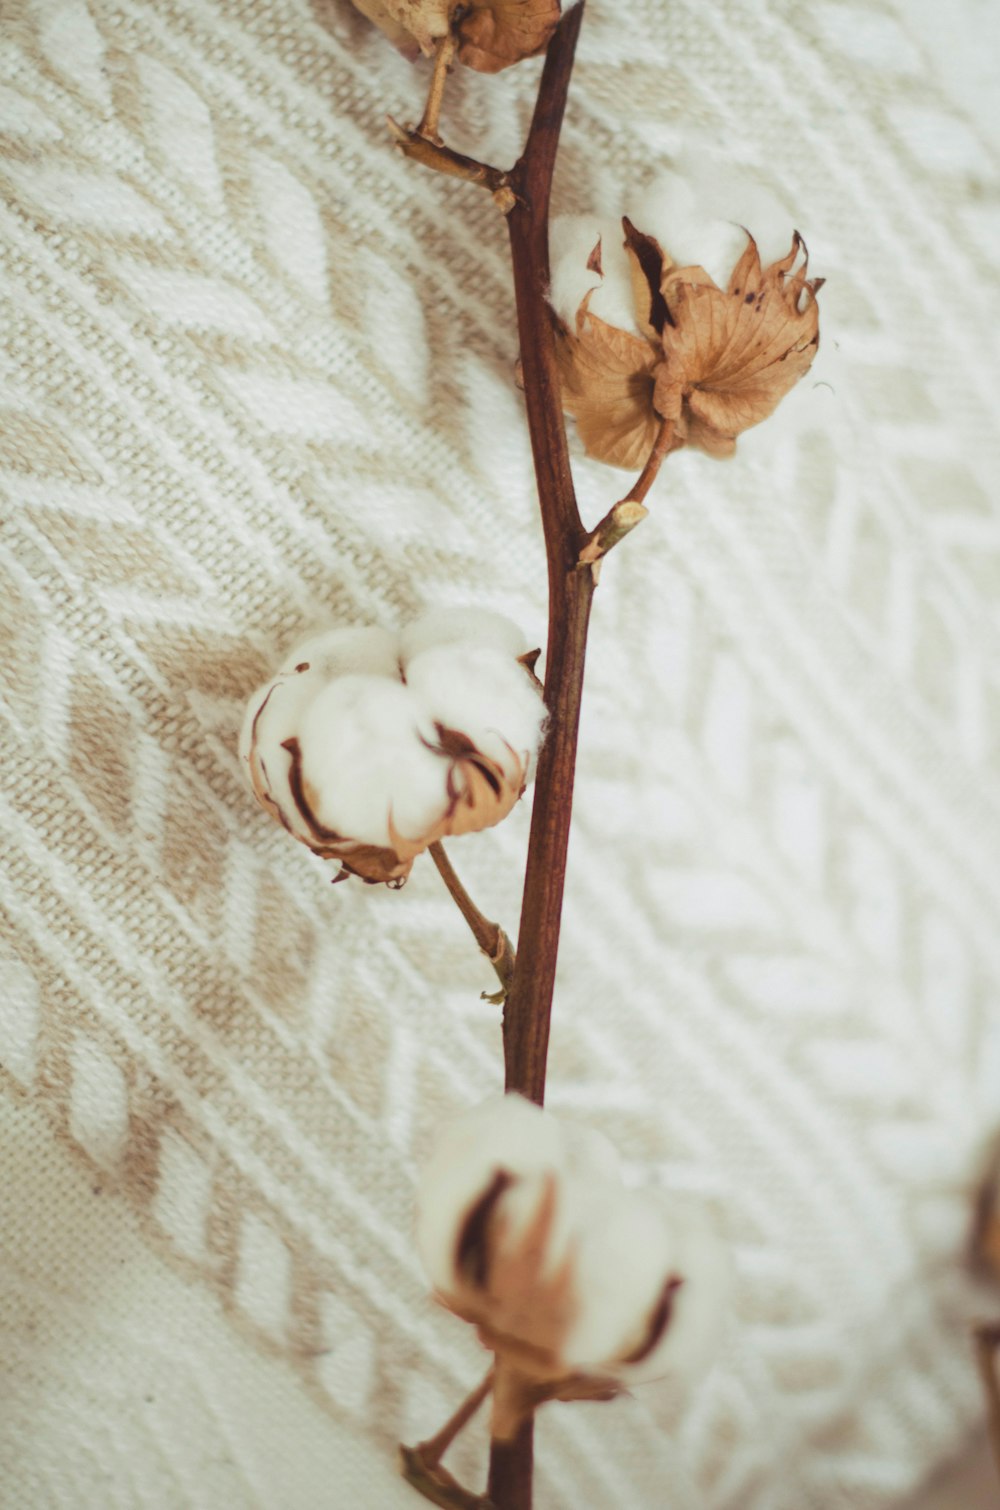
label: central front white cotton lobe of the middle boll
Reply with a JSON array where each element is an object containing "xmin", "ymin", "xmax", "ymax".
[{"xmin": 299, "ymin": 676, "xmax": 447, "ymax": 846}]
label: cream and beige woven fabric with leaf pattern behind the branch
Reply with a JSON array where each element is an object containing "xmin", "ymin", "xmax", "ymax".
[{"xmin": 0, "ymin": 0, "xmax": 1000, "ymax": 1510}]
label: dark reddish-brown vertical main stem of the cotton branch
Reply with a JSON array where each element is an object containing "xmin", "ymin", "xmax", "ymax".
[{"xmin": 488, "ymin": 3, "xmax": 594, "ymax": 1510}]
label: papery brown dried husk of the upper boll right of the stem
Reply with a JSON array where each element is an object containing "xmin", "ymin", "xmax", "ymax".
[{"xmin": 557, "ymin": 219, "xmax": 823, "ymax": 468}]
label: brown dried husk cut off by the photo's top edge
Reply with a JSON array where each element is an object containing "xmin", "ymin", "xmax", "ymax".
[{"xmin": 353, "ymin": 0, "xmax": 559, "ymax": 74}]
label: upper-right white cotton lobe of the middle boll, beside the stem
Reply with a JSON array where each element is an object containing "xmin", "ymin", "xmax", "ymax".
[{"xmin": 406, "ymin": 645, "xmax": 545, "ymax": 781}]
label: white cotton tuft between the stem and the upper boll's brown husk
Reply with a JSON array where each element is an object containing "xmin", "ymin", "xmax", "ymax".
[{"xmin": 548, "ymin": 214, "xmax": 636, "ymax": 331}]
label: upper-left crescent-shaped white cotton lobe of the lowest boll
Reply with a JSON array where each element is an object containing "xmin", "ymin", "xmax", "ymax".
[{"xmin": 415, "ymin": 1096, "xmax": 563, "ymax": 1291}]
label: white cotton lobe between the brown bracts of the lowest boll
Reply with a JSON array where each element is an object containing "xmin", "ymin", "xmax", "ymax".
[{"xmin": 563, "ymin": 1187, "xmax": 682, "ymax": 1368}]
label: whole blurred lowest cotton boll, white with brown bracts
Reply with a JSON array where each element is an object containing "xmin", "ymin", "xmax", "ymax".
[{"xmin": 417, "ymin": 1096, "xmax": 737, "ymax": 1441}]
